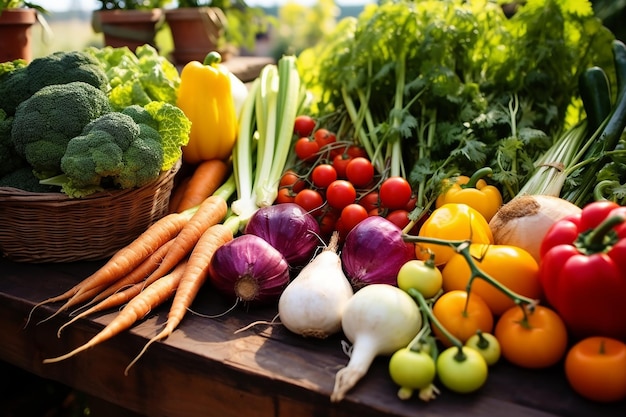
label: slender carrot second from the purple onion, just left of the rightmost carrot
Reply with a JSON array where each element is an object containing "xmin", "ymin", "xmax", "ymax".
[{"xmin": 43, "ymin": 262, "xmax": 185, "ymax": 363}]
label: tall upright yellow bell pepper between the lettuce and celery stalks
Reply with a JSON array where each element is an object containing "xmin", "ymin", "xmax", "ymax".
[{"xmin": 176, "ymin": 52, "xmax": 238, "ymax": 164}]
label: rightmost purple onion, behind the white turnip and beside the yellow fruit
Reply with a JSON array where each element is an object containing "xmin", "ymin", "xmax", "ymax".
[{"xmin": 341, "ymin": 216, "xmax": 413, "ymax": 288}]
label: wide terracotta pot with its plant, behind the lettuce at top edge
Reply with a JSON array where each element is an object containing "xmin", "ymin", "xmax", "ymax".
[{"xmin": 92, "ymin": 0, "xmax": 171, "ymax": 51}]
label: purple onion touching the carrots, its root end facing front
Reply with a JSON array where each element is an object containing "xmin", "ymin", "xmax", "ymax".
[{"xmin": 209, "ymin": 235, "xmax": 289, "ymax": 304}]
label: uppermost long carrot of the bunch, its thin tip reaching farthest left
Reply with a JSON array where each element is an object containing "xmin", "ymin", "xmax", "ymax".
[{"xmin": 26, "ymin": 213, "xmax": 189, "ymax": 325}]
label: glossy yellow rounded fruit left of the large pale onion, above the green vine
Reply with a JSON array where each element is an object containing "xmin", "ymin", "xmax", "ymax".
[{"xmin": 415, "ymin": 203, "xmax": 493, "ymax": 265}]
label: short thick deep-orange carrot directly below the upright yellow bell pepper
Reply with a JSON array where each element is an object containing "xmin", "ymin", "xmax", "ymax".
[{"xmin": 176, "ymin": 159, "xmax": 230, "ymax": 212}]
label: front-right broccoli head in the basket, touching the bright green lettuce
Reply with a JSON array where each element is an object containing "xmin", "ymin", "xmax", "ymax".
[{"xmin": 56, "ymin": 112, "xmax": 163, "ymax": 197}]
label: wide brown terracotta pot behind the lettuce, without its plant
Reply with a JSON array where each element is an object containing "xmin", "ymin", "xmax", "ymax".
[{"xmin": 92, "ymin": 9, "xmax": 163, "ymax": 51}]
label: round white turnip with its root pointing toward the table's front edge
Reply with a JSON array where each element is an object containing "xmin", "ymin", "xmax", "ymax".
[{"xmin": 330, "ymin": 284, "xmax": 422, "ymax": 402}]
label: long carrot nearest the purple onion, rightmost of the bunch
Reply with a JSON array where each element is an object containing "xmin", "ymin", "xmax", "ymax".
[{"xmin": 125, "ymin": 224, "xmax": 233, "ymax": 374}]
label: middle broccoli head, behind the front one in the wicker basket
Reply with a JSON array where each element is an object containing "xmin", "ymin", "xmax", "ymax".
[{"xmin": 11, "ymin": 81, "xmax": 111, "ymax": 178}]
